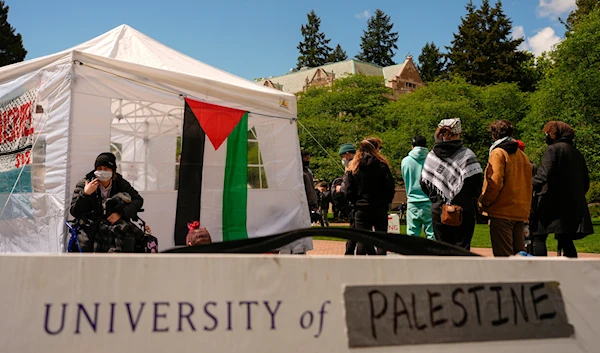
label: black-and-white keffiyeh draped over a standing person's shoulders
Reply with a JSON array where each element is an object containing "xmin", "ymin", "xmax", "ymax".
[{"xmin": 421, "ymin": 147, "xmax": 483, "ymax": 202}]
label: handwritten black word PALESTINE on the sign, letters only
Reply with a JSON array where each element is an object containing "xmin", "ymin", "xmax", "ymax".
[{"xmin": 369, "ymin": 283, "xmax": 556, "ymax": 338}]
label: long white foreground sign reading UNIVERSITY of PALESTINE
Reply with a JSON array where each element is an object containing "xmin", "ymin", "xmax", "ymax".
[{"xmin": 0, "ymin": 255, "xmax": 600, "ymax": 353}]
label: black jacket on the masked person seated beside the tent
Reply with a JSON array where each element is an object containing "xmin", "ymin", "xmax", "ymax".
[{"xmin": 71, "ymin": 171, "xmax": 144, "ymax": 221}]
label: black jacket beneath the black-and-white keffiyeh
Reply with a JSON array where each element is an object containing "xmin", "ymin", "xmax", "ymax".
[{"xmin": 421, "ymin": 140, "xmax": 483, "ymax": 215}]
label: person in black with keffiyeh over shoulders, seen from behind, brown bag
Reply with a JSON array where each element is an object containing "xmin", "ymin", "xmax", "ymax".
[{"xmin": 421, "ymin": 119, "xmax": 483, "ymax": 250}]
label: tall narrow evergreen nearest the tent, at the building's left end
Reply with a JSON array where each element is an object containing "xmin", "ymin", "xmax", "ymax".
[{"xmin": 296, "ymin": 10, "xmax": 331, "ymax": 69}]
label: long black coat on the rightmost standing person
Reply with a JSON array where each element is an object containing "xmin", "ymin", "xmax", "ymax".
[{"xmin": 533, "ymin": 139, "xmax": 594, "ymax": 239}]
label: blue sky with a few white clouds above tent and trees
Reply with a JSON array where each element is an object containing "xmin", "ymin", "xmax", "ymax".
[{"xmin": 5, "ymin": 0, "xmax": 575, "ymax": 79}]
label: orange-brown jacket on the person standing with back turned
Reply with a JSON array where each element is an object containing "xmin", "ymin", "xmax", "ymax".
[{"xmin": 479, "ymin": 142, "xmax": 533, "ymax": 221}]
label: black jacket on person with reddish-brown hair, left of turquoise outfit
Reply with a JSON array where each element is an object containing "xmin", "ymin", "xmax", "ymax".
[{"xmin": 342, "ymin": 154, "xmax": 396, "ymax": 210}]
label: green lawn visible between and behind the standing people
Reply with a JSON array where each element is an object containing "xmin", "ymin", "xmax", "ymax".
[{"xmin": 313, "ymin": 222, "xmax": 600, "ymax": 254}]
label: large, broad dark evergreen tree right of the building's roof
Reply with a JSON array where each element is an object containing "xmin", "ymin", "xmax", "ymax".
[{"xmin": 446, "ymin": 0, "xmax": 527, "ymax": 86}]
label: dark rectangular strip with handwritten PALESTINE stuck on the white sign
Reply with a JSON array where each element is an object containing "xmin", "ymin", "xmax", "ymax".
[{"xmin": 344, "ymin": 282, "xmax": 574, "ymax": 348}]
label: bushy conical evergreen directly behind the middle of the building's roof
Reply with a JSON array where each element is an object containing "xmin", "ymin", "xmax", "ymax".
[{"xmin": 356, "ymin": 9, "xmax": 398, "ymax": 67}]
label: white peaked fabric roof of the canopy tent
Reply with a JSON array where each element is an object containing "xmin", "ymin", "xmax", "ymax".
[{"xmin": 0, "ymin": 25, "xmax": 291, "ymax": 96}]
